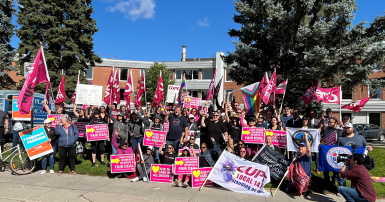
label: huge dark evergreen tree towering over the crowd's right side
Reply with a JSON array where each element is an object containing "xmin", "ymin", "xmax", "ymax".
[{"xmin": 224, "ymin": 0, "xmax": 385, "ymax": 107}]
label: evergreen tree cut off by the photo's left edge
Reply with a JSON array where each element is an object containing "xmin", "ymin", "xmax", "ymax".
[{"xmin": 0, "ymin": 0, "xmax": 17, "ymax": 90}]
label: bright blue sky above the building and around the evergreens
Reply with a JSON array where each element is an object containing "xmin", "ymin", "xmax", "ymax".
[{"xmin": 12, "ymin": 0, "xmax": 385, "ymax": 61}]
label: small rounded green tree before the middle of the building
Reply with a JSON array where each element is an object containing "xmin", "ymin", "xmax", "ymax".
[{"xmin": 146, "ymin": 62, "xmax": 175, "ymax": 103}]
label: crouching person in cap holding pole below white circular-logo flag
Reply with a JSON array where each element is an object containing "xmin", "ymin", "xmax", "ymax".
[{"xmin": 286, "ymin": 132, "xmax": 312, "ymax": 195}]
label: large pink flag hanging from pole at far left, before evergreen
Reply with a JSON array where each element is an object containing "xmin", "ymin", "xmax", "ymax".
[{"xmin": 17, "ymin": 48, "xmax": 49, "ymax": 114}]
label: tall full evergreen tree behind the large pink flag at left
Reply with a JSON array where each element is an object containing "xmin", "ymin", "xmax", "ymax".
[{"xmin": 16, "ymin": 0, "xmax": 102, "ymax": 103}]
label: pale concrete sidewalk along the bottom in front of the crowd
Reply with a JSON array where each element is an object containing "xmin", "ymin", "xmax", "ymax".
[{"xmin": 0, "ymin": 171, "xmax": 378, "ymax": 202}]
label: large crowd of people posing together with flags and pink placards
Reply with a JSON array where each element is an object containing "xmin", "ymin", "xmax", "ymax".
[{"xmin": 0, "ymin": 94, "xmax": 376, "ymax": 201}]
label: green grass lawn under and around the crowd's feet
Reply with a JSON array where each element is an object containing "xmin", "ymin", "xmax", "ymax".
[{"xmin": 3, "ymin": 144, "xmax": 385, "ymax": 198}]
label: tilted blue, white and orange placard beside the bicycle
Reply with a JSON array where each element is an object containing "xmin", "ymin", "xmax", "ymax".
[{"xmin": 19, "ymin": 126, "xmax": 53, "ymax": 160}]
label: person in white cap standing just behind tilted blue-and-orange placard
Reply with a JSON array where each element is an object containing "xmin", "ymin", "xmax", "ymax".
[{"xmin": 40, "ymin": 119, "xmax": 58, "ymax": 175}]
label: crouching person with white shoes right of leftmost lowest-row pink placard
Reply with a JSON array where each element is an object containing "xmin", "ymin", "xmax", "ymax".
[{"xmin": 131, "ymin": 146, "xmax": 155, "ymax": 182}]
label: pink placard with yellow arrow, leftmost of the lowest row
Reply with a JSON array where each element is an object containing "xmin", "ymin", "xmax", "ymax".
[{"xmin": 110, "ymin": 154, "xmax": 136, "ymax": 173}]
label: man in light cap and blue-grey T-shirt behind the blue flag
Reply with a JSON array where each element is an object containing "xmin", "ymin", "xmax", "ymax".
[{"xmin": 329, "ymin": 120, "xmax": 373, "ymax": 187}]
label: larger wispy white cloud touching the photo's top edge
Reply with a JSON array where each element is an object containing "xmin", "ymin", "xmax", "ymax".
[{"xmin": 107, "ymin": 0, "xmax": 155, "ymax": 21}]
